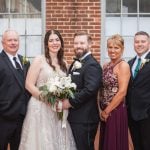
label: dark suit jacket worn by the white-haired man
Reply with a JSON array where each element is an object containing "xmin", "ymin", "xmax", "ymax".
[{"xmin": 0, "ymin": 51, "xmax": 30, "ymax": 120}]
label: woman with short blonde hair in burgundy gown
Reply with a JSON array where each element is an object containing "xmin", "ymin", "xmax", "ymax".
[{"xmin": 100, "ymin": 35, "xmax": 130, "ymax": 150}]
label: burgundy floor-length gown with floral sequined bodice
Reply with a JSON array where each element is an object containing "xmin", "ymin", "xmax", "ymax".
[{"xmin": 100, "ymin": 60, "xmax": 129, "ymax": 150}]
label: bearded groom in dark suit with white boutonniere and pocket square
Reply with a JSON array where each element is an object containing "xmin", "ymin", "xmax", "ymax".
[{"xmin": 63, "ymin": 31, "xmax": 102, "ymax": 150}]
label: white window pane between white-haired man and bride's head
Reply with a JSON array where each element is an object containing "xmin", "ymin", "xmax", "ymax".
[{"xmin": 26, "ymin": 36, "xmax": 42, "ymax": 57}]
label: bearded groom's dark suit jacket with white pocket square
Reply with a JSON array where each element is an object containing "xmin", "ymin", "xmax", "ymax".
[{"xmin": 68, "ymin": 55, "xmax": 102, "ymax": 123}]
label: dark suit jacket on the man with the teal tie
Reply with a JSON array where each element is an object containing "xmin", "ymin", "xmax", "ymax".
[{"xmin": 127, "ymin": 52, "xmax": 150, "ymax": 121}]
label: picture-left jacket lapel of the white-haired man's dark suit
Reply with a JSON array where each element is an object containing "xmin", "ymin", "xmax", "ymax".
[{"xmin": 2, "ymin": 51, "xmax": 24, "ymax": 89}]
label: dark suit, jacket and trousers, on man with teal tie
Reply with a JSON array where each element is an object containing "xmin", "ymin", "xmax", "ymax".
[{"xmin": 127, "ymin": 52, "xmax": 150, "ymax": 150}]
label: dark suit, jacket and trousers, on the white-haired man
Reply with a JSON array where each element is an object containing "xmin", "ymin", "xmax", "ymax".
[{"xmin": 0, "ymin": 51, "xmax": 30, "ymax": 150}]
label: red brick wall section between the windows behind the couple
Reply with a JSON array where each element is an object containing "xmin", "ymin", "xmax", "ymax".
[{"xmin": 46, "ymin": 0, "xmax": 101, "ymax": 63}]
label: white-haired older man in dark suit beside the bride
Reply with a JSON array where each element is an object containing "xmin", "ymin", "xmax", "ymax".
[{"xmin": 0, "ymin": 30, "xmax": 30, "ymax": 150}]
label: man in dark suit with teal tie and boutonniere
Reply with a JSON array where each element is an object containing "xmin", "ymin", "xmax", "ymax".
[{"xmin": 127, "ymin": 31, "xmax": 150, "ymax": 150}]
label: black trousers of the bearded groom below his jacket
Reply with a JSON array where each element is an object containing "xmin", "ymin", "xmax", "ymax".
[{"xmin": 70, "ymin": 123, "xmax": 98, "ymax": 150}]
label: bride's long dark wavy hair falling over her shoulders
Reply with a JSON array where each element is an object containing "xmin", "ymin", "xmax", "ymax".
[{"xmin": 44, "ymin": 30, "xmax": 67, "ymax": 72}]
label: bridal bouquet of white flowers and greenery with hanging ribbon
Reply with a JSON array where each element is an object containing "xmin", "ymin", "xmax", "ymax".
[{"xmin": 39, "ymin": 75, "xmax": 76, "ymax": 120}]
